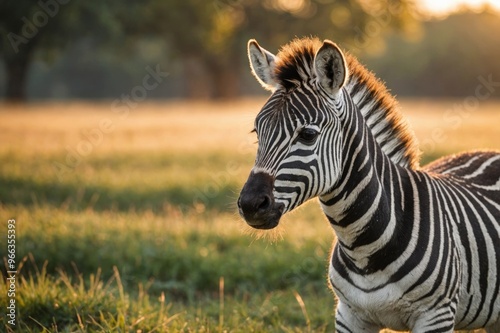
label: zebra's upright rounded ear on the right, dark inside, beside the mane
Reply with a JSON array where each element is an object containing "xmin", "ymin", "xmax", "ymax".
[{"xmin": 314, "ymin": 39, "xmax": 348, "ymax": 94}]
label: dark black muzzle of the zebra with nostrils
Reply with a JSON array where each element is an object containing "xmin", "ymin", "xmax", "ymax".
[{"xmin": 238, "ymin": 172, "xmax": 285, "ymax": 229}]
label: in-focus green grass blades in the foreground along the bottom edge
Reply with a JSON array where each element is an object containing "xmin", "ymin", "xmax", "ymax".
[{"xmin": 2, "ymin": 258, "xmax": 333, "ymax": 332}]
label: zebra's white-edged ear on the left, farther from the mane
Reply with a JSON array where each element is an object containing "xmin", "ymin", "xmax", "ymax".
[{"xmin": 248, "ymin": 39, "xmax": 278, "ymax": 91}]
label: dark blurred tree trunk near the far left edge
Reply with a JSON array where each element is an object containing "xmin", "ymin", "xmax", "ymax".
[{"xmin": 5, "ymin": 52, "xmax": 31, "ymax": 103}]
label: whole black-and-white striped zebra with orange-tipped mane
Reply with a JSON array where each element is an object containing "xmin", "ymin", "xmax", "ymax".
[{"xmin": 237, "ymin": 38, "xmax": 500, "ymax": 333}]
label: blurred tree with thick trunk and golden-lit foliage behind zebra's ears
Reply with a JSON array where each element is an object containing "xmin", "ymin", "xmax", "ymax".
[{"xmin": 131, "ymin": 0, "xmax": 416, "ymax": 98}]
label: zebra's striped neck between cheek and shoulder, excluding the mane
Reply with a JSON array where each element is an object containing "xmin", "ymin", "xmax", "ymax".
[{"xmin": 320, "ymin": 92, "xmax": 410, "ymax": 273}]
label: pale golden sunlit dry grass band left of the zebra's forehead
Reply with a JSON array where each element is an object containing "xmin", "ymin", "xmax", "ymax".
[{"xmin": 0, "ymin": 99, "xmax": 264, "ymax": 154}]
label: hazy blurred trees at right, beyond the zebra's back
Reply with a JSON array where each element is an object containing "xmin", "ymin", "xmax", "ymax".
[{"xmin": 363, "ymin": 8, "xmax": 500, "ymax": 97}]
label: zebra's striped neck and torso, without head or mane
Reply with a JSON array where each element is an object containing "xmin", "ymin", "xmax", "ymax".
[{"xmin": 320, "ymin": 92, "xmax": 500, "ymax": 332}]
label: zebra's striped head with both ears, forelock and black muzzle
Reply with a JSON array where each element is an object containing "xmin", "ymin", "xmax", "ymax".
[{"xmin": 238, "ymin": 39, "xmax": 348, "ymax": 229}]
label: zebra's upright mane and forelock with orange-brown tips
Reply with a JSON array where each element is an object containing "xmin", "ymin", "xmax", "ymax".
[{"xmin": 274, "ymin": 38, "xmax": 420, "ymax": 169}]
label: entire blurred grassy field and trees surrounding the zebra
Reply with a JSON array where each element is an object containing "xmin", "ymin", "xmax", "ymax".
[{"xmin": 0, "ymin": 0, "xmax": 500, "ymax": 333}]
